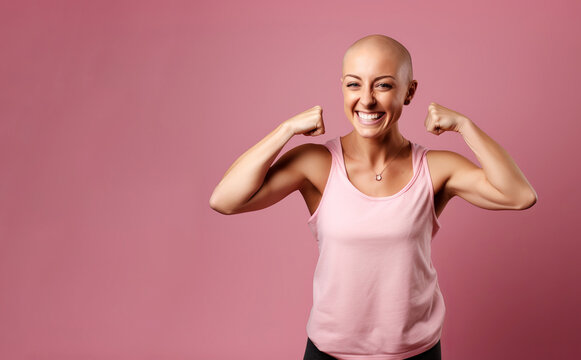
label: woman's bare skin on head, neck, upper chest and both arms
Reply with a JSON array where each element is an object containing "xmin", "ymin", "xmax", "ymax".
[{"xmin": 210, "ymin": 35, "xmax": 537, "ymax": 216}]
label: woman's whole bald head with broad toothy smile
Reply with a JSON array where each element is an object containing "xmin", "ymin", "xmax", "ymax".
[{"xmin": 341, "ymin": 35, "xmax": 417, "ymax": 137}]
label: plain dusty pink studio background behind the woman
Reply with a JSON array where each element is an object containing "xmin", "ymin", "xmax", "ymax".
[{"xmin": 0, "ymin": 0, "xmax": 581, "ymax": 360}]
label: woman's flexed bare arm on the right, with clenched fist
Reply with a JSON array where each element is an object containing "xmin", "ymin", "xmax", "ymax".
[{"xmin": 426, "ymin": 103, "xmax": 537, "ymax": 210}]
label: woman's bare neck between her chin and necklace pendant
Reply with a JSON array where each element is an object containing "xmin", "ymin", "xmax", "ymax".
[{"xmin": 343, "ymin": 128, "xmax": 407, "ymax": 169}]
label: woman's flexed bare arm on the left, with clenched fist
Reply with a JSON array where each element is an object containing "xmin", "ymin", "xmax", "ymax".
[{"xmin": 210, "ymin": 106, "xmax": 324, "ymax": 214}]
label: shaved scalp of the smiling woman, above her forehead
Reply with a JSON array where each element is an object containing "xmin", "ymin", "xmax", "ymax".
[{"xmin": 343, "ymin": 34, "xmax": 414, "ymax": 83}]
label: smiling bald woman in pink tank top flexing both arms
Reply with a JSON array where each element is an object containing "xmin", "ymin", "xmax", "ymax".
[{"xmin": 210, "ymin": 35, "xmax": 537, "ymax": 360}]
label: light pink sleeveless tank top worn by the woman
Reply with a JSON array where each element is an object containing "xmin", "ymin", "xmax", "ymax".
[{"xmin": 307, "ymin": 137, "xmax": 446, "ymax": 360}]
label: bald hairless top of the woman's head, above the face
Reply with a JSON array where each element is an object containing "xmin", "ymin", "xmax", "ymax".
[{"xmin": 343, "ymin": 34, "xmax": 414, "ymax": 83}]
